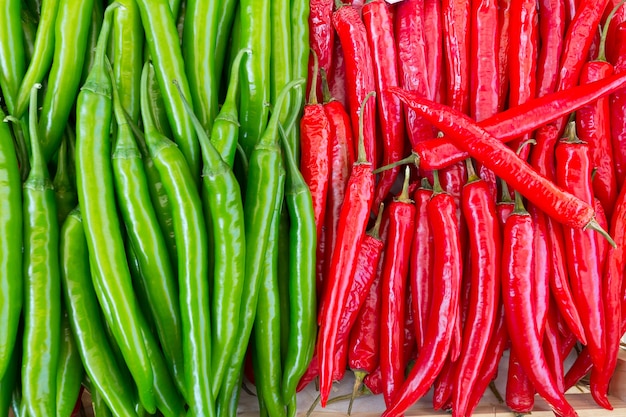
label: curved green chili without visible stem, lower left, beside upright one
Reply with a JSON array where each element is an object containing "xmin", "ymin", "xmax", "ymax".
[{"xmin": 59, "ymin": 209, "xmax": 137, "ymax": 417}]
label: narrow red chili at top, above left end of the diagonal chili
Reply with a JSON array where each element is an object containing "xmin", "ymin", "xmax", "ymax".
[{"xmin": 423, "ymin": 0, "xmax": 447, "ymax": 103}]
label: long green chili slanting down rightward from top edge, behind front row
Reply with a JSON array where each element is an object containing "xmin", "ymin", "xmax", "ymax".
[{"xmin": 137, "ymin": 0, "xmax": 200, "ymax": 179}]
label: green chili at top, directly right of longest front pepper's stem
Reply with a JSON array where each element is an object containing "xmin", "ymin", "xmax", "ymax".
[{"xmin": 111, "ymin": 0, "xmax": 144, "ymax": 123}]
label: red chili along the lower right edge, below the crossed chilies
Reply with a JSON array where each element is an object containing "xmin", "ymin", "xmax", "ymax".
[{"xmin": 590, "ymin": 187, "xmax": 626, "ymax": 409}]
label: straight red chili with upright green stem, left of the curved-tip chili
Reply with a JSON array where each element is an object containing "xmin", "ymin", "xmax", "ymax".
[{"xmin": 380, "ymin": 169, "xmax": 415, "ymax": 405}]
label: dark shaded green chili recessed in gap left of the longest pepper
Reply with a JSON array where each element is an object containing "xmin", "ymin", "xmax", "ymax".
[{"xmin": 52, "ymin": 133, "xmax": 78, "ymax": 225}]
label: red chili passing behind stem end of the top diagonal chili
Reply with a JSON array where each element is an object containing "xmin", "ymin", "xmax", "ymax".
[{"xmin": 556, "ymin": 142, "xmax": 606, "ymax": 369}]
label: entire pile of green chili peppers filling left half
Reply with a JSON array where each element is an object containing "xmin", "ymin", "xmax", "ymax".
[{"xmin": 0, "ymin": 0, "xmax": 317, "ymax": 417}]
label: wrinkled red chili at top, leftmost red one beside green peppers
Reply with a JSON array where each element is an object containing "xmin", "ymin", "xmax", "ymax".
[{"xmin": 307, "ymin": 0, "xmax": 335, "ymax": 98}]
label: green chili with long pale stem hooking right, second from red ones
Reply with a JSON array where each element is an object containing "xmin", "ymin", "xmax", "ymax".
[{"xmin": 218, "ymin": 79, "xmax": 304, "ymax": 415}]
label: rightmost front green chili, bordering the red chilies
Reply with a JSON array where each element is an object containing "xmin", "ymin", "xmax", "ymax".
[{"xmin": 282, "ymin": 126, "xmax": 317, "ymax": 411}]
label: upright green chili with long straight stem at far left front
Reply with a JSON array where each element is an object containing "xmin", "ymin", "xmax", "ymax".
[{"xmin": 22, "ymin": 84, "xmax": 61, "ymax": 416}]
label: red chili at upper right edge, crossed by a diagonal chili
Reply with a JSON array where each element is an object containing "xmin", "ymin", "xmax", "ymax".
[{"xmin": 609, "ymin": 22, "xmax": 626, "ymax": 189}]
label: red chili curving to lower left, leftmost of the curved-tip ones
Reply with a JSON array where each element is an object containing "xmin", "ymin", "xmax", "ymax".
[{"xmin": 382, "ymin": 170, "xmax": 463, "ymax": 417}]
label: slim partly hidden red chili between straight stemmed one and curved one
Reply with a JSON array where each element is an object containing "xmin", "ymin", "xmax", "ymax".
[{"xmin": 409, "ymin": 188, "xmax": 434, "ymax": 350}]
